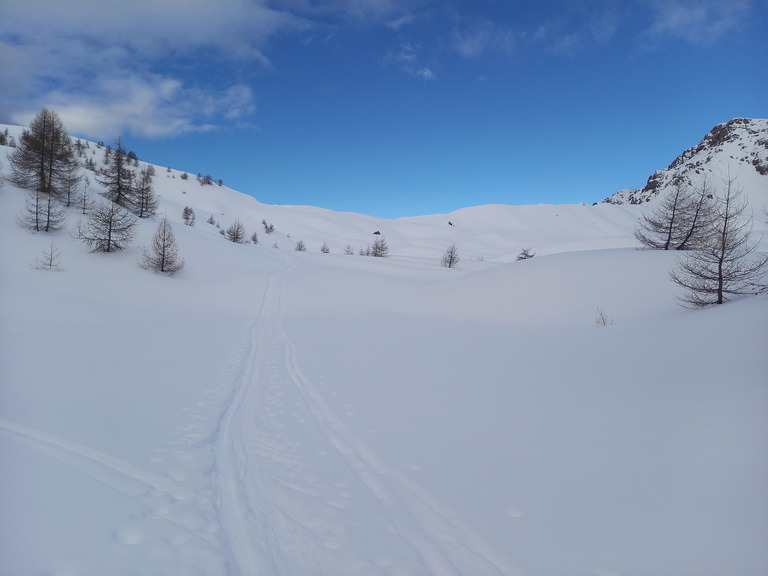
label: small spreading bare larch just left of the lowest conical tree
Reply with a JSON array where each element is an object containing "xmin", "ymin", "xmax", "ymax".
[{"xmin": 74, "ymin": 202, "xmax": 137, "ymax": 252}]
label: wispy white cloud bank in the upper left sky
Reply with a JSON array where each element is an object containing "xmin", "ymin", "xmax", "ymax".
[{"xmin": 0, "ymin": 0, "xmax": 292, "ymax": 138}]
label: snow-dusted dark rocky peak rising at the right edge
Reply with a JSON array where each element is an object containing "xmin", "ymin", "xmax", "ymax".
[{"xmin": 603, "ymin": 118, "xmax": 768, "ymax": 204}]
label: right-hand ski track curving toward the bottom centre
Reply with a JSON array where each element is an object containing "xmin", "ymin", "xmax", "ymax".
[{"xmin": 275, "ymin": 277, "xmax": 518, "ymax": 576}]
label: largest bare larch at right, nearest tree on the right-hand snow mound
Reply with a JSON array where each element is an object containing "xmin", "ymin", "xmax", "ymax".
[{"xmin": 670, "ymin": 176, "xmax": 768, "ymax": 308}]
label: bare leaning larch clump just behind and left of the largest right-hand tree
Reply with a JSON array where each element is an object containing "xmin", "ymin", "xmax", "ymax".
[{"xmin": 635, "ymin": 177, "xmax": 712, "ymax": 250}]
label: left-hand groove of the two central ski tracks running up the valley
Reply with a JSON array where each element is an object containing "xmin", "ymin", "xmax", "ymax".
[{"xmin": 213, "ymin": 260, "xmax": 291, "ymax": 576}]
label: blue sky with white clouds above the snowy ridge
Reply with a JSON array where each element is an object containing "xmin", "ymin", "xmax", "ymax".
[{"xmin": 0, "ymin": 0, "xmax": 768, "ymax": 218}]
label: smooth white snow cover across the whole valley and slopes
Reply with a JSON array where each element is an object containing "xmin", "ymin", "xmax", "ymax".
[{"xmin": 0, "ymin": 119, "xmax": 768, "ymax": 576}]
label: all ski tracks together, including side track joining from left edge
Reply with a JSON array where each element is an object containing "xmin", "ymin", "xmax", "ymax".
[{"xmin": 0, "ymin": 257, "xmax": 517, "ymax": 576}]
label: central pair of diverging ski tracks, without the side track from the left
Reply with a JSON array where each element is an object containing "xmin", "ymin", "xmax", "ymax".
[{"xmin": 207, "ymin": 262, "xmax": 516, "ymax": 576}]
